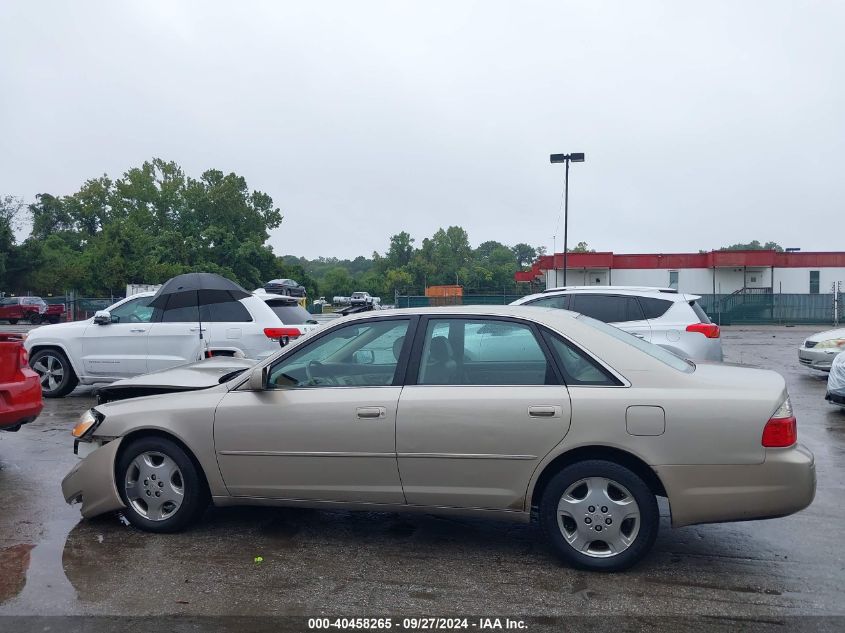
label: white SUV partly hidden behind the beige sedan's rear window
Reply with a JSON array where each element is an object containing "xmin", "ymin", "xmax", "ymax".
[{"xmin": 511, "ymin": 286, "xmax": 722, "ymax": 361}]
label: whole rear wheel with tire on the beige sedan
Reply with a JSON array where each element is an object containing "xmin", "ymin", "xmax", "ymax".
[{"xmin": 540, "ymin": 460, "xmax": 660, "ymax": 571}]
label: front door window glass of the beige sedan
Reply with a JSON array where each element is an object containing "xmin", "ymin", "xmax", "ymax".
[{"xmin": 267, "ymin": 319, "xmax": 409, "ymax": 389}]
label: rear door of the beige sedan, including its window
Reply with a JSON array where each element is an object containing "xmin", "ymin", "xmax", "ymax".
[{"xmin": 396, "ymin": 317, "xmax": 570, "ymax": 510}]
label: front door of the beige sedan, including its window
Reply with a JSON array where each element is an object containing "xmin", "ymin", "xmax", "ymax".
[{"xmin": 214, "ymin": 318, "xmax": 411, "ymax": 504}]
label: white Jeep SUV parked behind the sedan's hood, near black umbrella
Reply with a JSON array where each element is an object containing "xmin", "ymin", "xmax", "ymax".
[{"xmin": 24, "ymin": 292, "xmax": 294, "ymax": 398}]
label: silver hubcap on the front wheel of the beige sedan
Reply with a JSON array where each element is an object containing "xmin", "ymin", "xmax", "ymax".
[{"xmin": 125, "ymin": 451, "xmax": 185, "ymax": 521}]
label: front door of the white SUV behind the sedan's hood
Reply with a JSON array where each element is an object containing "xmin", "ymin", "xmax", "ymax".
[{"xmin": 82, "ymin": 297, "xmax": 153, "ymax": 380}]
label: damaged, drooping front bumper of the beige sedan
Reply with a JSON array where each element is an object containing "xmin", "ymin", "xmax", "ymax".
[{"xmin": 62, "ymin": 438, "xmax": 126, "ymax": 519}]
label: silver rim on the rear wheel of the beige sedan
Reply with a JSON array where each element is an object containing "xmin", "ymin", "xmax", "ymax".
[{"xmin": 557, "ymin": 477, "xmax": 640, "ymax": 558}]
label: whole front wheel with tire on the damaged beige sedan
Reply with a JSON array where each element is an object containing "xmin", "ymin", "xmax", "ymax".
[{"xmin": 116, "ymin": 437, "xmax": 209, "ymax": 532}]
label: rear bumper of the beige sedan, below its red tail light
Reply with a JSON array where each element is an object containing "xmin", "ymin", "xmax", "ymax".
[{"xmin": 655, "ymin": 444, "xmax": 816, "ymax": 527}]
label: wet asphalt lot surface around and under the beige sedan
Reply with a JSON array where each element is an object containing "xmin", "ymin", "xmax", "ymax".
[{"xmin": 0, "ymin": 327, "xmax": 845, "ymax": 622}]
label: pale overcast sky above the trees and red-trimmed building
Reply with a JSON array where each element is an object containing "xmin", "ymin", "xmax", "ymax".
[{"xmin": 0, "ymin": 0, "xmax": 845, "ymax": 257}]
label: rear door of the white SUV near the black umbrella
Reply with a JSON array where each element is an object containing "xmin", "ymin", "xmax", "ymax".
[{"xmin": 147, "ymin": 306, "xmax": 208, "ymax": 371}]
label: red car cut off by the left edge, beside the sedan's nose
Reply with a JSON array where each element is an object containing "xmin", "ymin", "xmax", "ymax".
[{"xmin": 0, "ymin": 332, "xmax": 44, "ymax": 431}]
